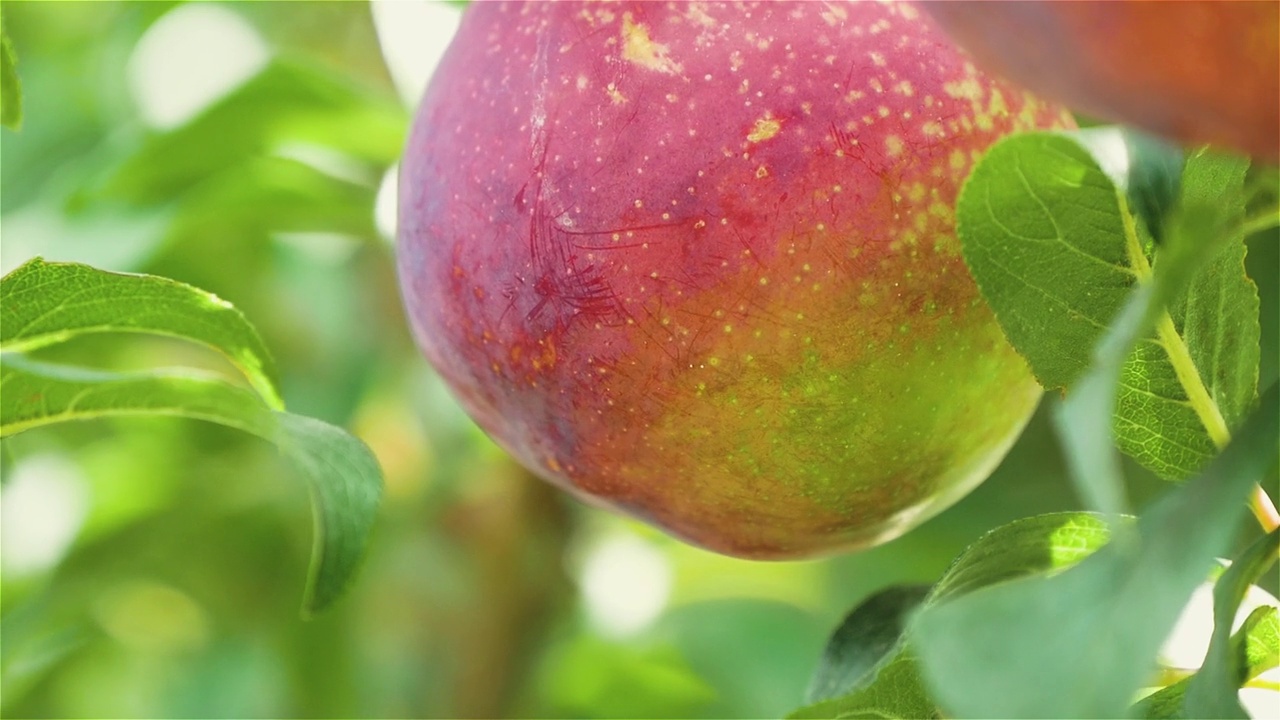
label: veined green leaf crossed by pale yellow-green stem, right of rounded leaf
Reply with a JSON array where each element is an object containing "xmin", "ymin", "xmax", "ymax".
[{"xmin": 1115, "ymin": 152, "xmax": 1260, "ymax": 479}]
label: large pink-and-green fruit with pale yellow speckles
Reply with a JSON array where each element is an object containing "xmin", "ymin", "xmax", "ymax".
[{"xmin": 398, "ymin": 3, "xmax": 1071, "ymax": 559}]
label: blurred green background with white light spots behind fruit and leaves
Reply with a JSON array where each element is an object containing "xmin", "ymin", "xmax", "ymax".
[{"xmin": 0, "ymin": 0, "xmax": 1280, "ymax": 717}]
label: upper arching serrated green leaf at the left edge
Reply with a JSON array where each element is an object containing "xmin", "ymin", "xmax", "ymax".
[{"xmin": 0, "ymin": 258, "xmax": 284, "ymax": 410}]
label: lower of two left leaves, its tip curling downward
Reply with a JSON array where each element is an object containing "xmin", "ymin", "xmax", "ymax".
[{"xmin": 0, "ymin": 352, "xmax": 381, "ymax": 612}]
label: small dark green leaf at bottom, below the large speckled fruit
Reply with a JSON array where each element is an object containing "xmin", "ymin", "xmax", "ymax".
[{"xmin": 805, "ymin": 585, "xmax": 929, "ymax": 703}]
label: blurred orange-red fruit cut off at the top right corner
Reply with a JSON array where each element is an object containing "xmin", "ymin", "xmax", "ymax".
[{"xmin": 924, "ymin": 0, "xmax": 1280, "ymax": 163}]
